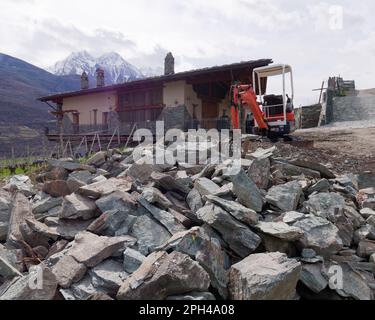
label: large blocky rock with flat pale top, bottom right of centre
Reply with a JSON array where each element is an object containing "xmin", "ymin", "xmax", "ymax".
[{"xmin": 229, "ymin": 252, "xmax": 301, "ymax": 300}]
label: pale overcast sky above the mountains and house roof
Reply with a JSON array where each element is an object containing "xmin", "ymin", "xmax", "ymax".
[{"xmin": 0, "ymin": 0, "xmax": 375, "ymax": 105}]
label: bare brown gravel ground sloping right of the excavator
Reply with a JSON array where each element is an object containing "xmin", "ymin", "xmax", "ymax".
[{"xmin": 244, "ymin": 121, "xmax": 375, "ymax": 174}]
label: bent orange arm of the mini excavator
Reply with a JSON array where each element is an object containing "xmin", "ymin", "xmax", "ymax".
[{"xmin": 231, "ymin": 85, "xmax": 268, "ymax": 130}]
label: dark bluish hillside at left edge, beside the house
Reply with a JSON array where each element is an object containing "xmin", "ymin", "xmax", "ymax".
[{"xmin": 0, "ymin": 53, "xmax": 80, "ymax": 158}]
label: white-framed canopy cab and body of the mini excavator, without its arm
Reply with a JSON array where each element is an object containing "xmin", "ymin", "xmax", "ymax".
[{"xmin": 253, "ymin": 64, "xmax": 295, "ymax": 136}]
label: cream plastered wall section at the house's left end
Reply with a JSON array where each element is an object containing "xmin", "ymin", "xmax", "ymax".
[{"xmin": 63, "ymin": 91, "xmax": 117, "ymax": 125}]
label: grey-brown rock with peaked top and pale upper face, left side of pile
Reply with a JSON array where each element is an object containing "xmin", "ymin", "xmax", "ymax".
[{"xmin": 59, "ymin": 193, "xmax": 98, "ymax": 220}]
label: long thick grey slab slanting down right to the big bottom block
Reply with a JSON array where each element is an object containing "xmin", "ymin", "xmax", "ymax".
[{"xmin": 197, "ymin": 204, "xmax": 261, "ymax": 258}]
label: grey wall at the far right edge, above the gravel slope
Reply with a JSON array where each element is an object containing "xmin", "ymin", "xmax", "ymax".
[{"xmin": 332, "ymin": 95, "xmax": 375, "ymax": 122}]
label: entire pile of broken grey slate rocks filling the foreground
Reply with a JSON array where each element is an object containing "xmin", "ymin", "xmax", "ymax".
[{"xmin": 0, "ymin": 140, "xmax": 375, "ymax": 300}]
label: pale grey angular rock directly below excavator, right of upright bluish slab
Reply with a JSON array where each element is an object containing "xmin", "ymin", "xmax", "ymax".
[{"xmin": 266, "ymin": 181, "xmax": 302, "ymax": 211}]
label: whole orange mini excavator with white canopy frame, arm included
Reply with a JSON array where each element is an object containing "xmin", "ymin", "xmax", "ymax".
[{"xmin": 231, "ymin": 64, "xmax": 295, "ymax": 138}]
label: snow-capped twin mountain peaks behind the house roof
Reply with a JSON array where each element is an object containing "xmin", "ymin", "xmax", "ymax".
[{"xmin": 50, "ymin": 51, "xmax": 145, "ymax": 86}]
